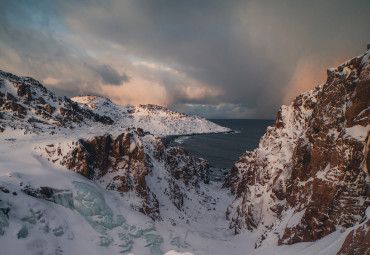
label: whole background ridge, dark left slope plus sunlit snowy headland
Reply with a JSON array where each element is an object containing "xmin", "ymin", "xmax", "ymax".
[{"xmin": 0, "ymin": 71, "xmax": 230, "ymax": 136}]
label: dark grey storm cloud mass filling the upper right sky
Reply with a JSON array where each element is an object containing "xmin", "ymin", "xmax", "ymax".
[{"xmin": 55, "ymin": 1, "xmax": 369, "ymax": 116}]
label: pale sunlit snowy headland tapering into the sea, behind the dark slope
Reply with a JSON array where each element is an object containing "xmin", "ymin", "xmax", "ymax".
[{"xmin": 72, "ymin": 96, "xmax": 231, "ymax": 136}]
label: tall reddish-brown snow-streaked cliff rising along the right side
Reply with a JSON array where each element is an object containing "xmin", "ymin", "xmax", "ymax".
[{"xmin": 224, "ymin": 48, "xmax": 370, "ymax": 246}]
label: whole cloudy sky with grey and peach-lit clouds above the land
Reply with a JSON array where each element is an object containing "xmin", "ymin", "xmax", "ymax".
[{"xmin": 0, "ymin": 0, "xmax": 370, "ymax": 119}]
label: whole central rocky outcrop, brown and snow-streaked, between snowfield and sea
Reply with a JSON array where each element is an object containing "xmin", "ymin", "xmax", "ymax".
[{"xmin": 36, "ymin": 129, "xmax": 209, "ymax": 219}]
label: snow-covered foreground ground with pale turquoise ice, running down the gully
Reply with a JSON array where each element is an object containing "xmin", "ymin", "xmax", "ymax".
[{"xmin": 0, "ymin": 130, "xmax": 351, "ymax": 255}]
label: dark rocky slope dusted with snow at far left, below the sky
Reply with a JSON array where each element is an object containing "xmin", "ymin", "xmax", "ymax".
[{"xmin": 0, "ymin": 71, "xmax": 113, "ymax": 132}]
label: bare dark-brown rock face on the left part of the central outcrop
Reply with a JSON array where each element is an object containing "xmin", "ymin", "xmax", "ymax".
[{"xmin": 61, "ymin": 133, "xmax": 160, "ymax": 219}]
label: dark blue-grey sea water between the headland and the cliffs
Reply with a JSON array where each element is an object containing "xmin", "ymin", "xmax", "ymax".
[{"xmin": 163, "ymin": 119, "xmax": 274, "ymax": 181}]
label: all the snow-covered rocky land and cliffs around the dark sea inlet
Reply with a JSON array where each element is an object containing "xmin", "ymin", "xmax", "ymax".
[{"xmin": 0, "ymin": 47, "xmax": 370, "ymax": 255}]
